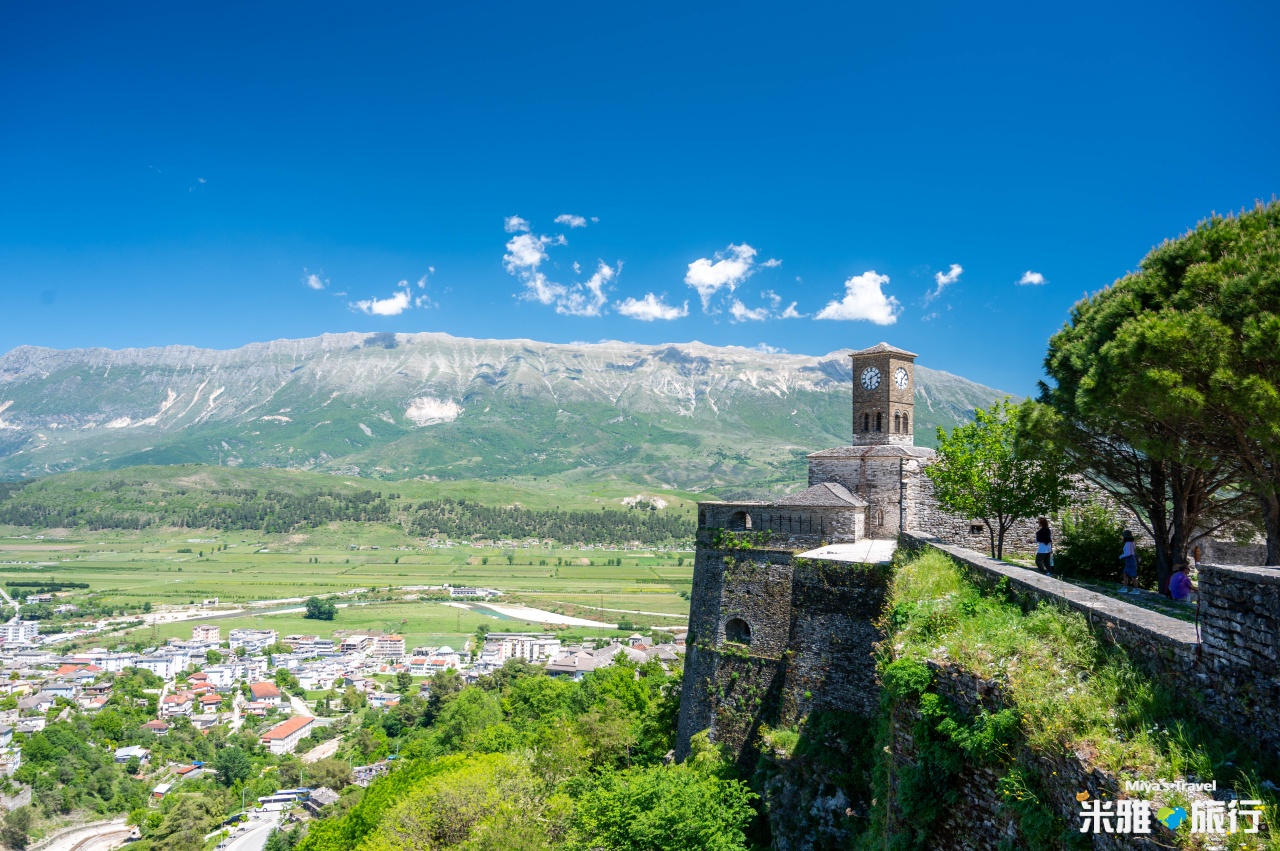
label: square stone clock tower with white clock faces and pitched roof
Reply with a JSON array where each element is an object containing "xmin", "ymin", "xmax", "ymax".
[{"xmin": 849, "ymin": 343, "xmax": 918, "ymax": 447}]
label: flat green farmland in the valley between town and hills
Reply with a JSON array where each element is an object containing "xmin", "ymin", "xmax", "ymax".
[{"xmin": 0, "ymin": 523, "xmax": 692, "ymax": 648}]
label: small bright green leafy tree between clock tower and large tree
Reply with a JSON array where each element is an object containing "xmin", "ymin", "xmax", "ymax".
[{"xmin": 925, "ymin": 399, "xmax": 1070, "ymax": 558}]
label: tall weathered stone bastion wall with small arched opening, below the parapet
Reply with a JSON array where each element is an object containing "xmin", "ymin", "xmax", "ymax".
[{"xmin": 676, "ymin": 540, "xmax": 888, "ymax": 769}]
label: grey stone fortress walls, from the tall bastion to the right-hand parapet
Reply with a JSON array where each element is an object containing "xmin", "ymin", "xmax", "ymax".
[{"xmin": 676, "ymin": 344, "xmax": 1280, "ymax": 768}]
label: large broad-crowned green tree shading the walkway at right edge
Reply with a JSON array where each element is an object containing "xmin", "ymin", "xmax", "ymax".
[{"xmin": 1042, "ymin": 203, "xmax": 1280, "ymax": 573}]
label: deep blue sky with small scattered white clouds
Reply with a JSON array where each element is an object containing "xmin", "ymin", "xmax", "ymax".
[{"xmin": 0, "ymin": 3, "xmax": 1280, "ymax": 393}]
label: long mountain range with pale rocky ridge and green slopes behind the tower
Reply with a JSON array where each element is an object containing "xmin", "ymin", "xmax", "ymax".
[{"xmin": 0, "ymin": 333, "xmax": 1005, "ymax": 493}]
